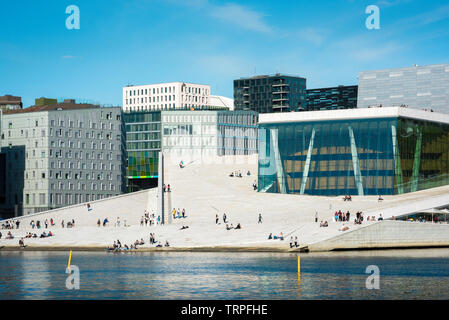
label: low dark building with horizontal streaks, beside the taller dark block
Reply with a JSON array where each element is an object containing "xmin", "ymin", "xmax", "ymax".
[{"xmin": 307, "ymin": 86, "xmax": 358, "ymax": 111}]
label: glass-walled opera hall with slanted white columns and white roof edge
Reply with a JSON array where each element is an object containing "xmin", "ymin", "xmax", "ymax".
[{"xmin": 258, "ymin": 108, "xmax": 449, "ymax": 196}]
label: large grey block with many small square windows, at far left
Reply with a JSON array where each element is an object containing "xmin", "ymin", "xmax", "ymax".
[{"xmin": 1, "ymin": 103, "xmax": 124, "ymax": 214}]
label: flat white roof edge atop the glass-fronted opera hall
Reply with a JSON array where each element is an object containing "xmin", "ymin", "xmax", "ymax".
[{"xmin": 259, "ymin": 107, "xmax": 449, "ymax": 124}]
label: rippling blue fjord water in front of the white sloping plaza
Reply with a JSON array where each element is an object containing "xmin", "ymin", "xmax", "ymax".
[{"xmin": 0, "ymin": 249, "xmax": 449, "ymax": 300}]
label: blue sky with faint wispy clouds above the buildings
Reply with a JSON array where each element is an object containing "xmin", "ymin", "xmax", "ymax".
[{"xmin": 0, "ymin": 0, "xmax": 449, "ymax": 107}]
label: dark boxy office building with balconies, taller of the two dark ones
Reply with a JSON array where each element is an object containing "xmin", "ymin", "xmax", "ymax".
[{"xmin": 234, "ymin": 73, "xmax": 307, "ymax": 113}]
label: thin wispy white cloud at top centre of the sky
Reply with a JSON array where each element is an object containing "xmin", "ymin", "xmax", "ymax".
[{"xmin": 210, "ymin": 3, "xmax": 272, "ymax": 33}]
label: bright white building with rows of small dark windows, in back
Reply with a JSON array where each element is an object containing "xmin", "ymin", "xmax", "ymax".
[{"xmin": 123, "ymin": 82, "xmax": 210, "ymax": 112}]
